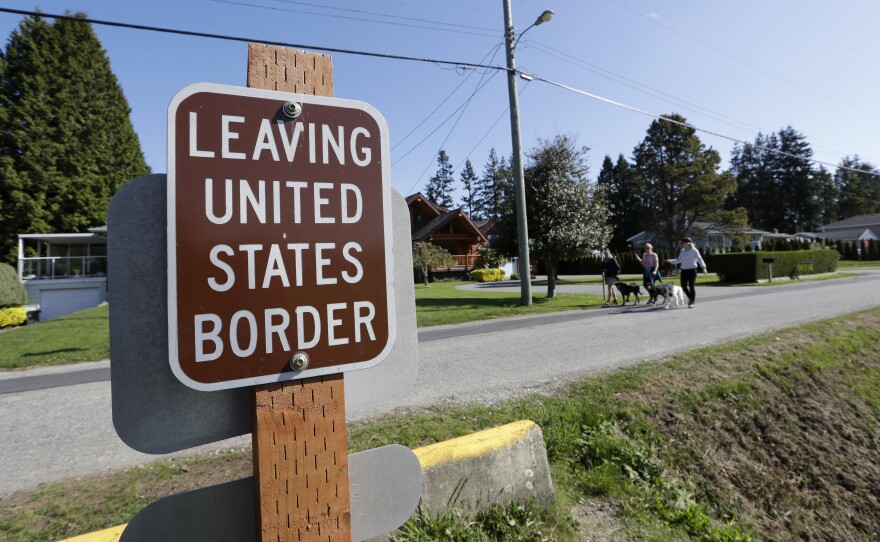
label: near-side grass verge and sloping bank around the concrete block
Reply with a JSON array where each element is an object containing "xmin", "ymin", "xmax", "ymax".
[{"xmin": 0, "ymin": 309, "xmax": 880, "ymax": 541}]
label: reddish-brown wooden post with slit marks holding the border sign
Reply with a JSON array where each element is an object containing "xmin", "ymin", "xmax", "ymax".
[{"xmin": 247, "ymin": 44, "xmax": 351, "ymax": 542}]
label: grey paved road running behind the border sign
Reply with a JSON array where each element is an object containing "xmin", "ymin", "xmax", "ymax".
[{"xmin": 0, "ymin": 272, "xmax": 880, "ymax": 495}]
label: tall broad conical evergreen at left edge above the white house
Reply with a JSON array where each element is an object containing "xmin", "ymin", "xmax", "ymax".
[{"xmin": 0, "ymin": 13, "xmax": 149, "ymax": 261}]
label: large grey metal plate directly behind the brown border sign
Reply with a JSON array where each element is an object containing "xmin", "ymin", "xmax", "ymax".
[{"xmin": 107, "ymin": 175, "xmax": 418, "ymax": 454}]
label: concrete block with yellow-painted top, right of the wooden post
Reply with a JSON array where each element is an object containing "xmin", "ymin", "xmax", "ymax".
[{"xmin": 413, "ymin": 420, "xmax": 554, "ymax": 512}]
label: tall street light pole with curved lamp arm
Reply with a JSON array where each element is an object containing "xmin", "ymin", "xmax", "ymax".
[{"xmin": 504, "ymin": 0, "xmax": 553, "ymax": 306}]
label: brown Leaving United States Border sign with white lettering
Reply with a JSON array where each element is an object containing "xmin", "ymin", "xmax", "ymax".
[{"xmin": 168, "ymin": 83, "xmax": 396, "ymax": 390}]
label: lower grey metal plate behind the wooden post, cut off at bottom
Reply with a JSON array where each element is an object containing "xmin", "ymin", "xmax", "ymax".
[{"xmin": 120, "ymin": 444, "xmax": 422, "ymax": 542}]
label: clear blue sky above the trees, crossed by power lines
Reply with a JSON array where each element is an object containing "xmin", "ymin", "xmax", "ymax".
[{"xmin": 0, "ymin": 0, "xmax": 880, "ymax": 202}]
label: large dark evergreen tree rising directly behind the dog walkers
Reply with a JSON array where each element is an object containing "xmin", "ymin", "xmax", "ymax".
[{"xmin": 633, "ymin": 114, "xmax": 745, "ymax": 252}]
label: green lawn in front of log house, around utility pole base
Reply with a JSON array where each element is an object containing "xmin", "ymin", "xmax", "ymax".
[{"xmin": 416, "ymin": 281, "xmax": 602, "ymax": 327}]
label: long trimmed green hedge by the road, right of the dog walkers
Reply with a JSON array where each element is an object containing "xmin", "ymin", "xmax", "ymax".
[{"xmin": 706, "ymin": 250, "xmax": 838, "ymax": 282}]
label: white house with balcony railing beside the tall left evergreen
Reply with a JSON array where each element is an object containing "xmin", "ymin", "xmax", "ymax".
[{"xmin": 18, "ymin": 226, "xmax": 108, "ymax": 320}]
